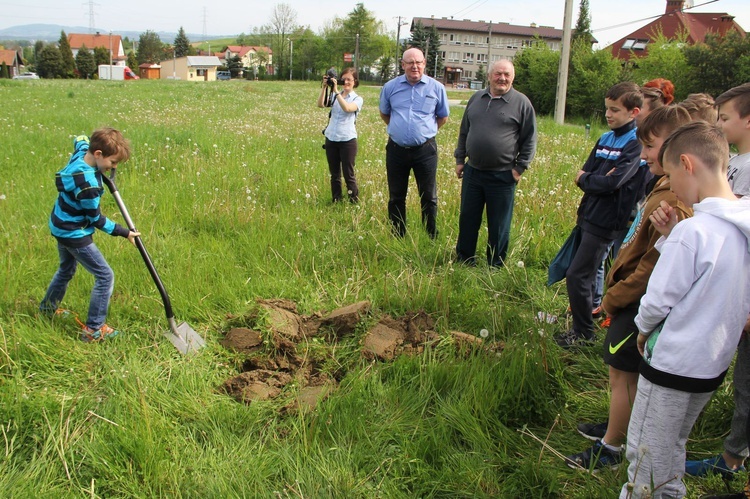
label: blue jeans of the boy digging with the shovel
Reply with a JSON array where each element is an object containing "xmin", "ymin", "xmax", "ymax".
[{"xmin": 39, "ymin": 242, "xmax": 115, "ymax": 331}]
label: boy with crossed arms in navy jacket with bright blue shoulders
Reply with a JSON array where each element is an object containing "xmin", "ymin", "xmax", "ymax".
[{"xmin": 555, "ymin": 82, "xmax": 652, "ymax": 348}]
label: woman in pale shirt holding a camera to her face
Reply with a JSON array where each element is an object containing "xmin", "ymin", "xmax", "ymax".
[{"xmin": 318, "ymin": 68, "xmax": 363, "ymax": 203}]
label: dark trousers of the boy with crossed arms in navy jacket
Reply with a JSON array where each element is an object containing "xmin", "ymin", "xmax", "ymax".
[{"xmin": 565, "ymin": 229, "xmax": 613, "ymax": 338}]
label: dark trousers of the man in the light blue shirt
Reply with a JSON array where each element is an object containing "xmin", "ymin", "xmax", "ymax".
[{"xmin": 385, "ymin": 138, "xmax": 437, "ymax": 239}]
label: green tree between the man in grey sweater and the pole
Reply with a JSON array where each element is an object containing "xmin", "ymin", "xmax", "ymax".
[{"xmin": 513, "ymin": 43, "xmax": 560, "ymax": 114}]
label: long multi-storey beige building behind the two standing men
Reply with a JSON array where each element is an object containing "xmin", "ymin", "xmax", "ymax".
[{"xmin": 411, "ymin": 17, "xmax": 576, "ymax": 86}]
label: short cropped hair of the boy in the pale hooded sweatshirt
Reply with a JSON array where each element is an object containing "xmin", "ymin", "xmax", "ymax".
[{"xmin": 659, "ymin": 121, "xmax": 729, "ymax": 173}]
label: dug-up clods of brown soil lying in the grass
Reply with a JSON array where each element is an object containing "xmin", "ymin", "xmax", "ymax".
[{"xmin": 220, "ymin": 299, "xmax": 490, "ymax": 410}]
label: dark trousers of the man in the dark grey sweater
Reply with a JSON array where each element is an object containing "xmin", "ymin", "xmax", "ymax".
[{"xmin": 456, "ymin": 164, "xmax": 516, "ymax": 267}]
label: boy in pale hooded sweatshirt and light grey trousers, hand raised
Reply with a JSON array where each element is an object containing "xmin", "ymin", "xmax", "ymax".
[{"xmin": 620, "ymin": 121, "xmax": 750, "ymax": 499}]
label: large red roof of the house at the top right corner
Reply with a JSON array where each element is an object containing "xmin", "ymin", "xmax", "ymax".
[{"xmin": 610, "ymin": 0, "xmax": 745, "ymax": 61}]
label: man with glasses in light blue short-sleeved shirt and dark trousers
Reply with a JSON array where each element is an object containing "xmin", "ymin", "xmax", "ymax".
[{"xmin": 380, "ymin": 48, "xmax": 449, "ymax": 239}]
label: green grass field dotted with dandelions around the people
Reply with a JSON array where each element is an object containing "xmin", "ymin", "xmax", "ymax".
[{"xmin": 0, "ymin": 80, "xmax": 746, "ymax": 498}]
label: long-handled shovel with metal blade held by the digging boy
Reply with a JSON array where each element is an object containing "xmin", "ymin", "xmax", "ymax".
[{"xmin": 102, "ymin": 170, "xmax": 206, "ymax": 355}]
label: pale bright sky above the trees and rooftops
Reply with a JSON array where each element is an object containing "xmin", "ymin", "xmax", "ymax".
[{"xmin": 0, "ymin": 0, "xmax": 750, "ymax": 47}]
